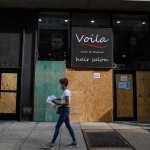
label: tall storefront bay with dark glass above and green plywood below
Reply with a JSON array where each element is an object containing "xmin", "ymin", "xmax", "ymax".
[{"xmin": 34, "ymin": 14, "xmax": 69, "ymax": 122}]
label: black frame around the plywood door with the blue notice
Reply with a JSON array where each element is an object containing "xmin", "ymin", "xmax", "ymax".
[{"xmin": 113, "ymin": 70, "xmax": 137, "ymax": 121}]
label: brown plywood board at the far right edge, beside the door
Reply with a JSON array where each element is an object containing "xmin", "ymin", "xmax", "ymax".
[{"xmin": 136, "ymin": 71, "xmax": 150, "ymax": 122}]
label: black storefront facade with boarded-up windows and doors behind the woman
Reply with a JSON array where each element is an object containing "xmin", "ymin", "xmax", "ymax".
[{"xmin": 0, "ymin": 1, "xmax": 150, "ymax": 122}]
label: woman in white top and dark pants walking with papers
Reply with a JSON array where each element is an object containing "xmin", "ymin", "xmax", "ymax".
[{"xmin": 43, "ymin": 78, "xmax": 77, "ymax": 149}]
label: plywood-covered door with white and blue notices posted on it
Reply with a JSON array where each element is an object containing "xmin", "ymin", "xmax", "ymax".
[{"xmin": 114, "ymin": 71, "xmax": 137, "ymax": 121}]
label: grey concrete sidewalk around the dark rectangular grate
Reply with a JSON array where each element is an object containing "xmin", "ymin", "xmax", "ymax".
[{"xmin": 0, "ymin": 122, "xmax": 150, "ymax": 150}]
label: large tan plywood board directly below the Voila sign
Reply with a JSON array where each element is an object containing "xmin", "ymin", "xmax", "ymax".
[{"xmin": 65, "ymin": 69, "xmax": 113, "ymax": 122}]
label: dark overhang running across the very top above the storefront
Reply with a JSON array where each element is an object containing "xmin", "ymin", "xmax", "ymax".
[{"xmin": 0, "ymin": 0, "xmax": 150, "ymax": 11}]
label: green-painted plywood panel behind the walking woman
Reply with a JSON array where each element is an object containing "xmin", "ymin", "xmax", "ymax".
[{"xmin": 34, "ymin": 61, "xmax": 65, "ymax": 122}]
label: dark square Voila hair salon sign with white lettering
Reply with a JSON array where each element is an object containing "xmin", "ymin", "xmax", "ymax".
[{"xmin": 71, "ymin": 27, "xmax": 113, "ymax": 68}]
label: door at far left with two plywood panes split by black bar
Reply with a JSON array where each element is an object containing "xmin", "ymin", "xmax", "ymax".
[{"xmin": 0, "ymin": 72, "xmax": 18, "ymax": 119}]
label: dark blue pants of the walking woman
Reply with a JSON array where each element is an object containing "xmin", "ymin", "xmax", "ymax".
[{"xmin": 51, "ymin": 107, "xmax": 76, "ymax": 144}]
